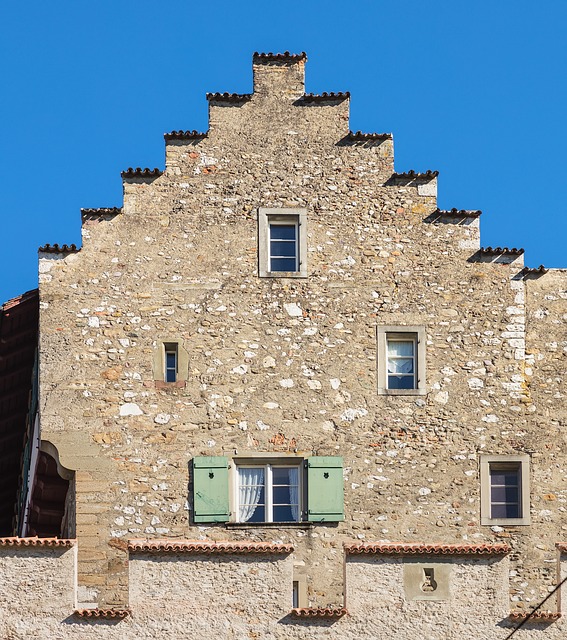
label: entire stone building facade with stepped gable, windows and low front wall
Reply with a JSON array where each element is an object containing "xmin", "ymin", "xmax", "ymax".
[{"xmin": 0, "ymin": 53, "xmax": 567, "ymax": 640}]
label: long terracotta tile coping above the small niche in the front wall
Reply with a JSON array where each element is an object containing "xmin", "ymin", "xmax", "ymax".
[{"xmin": 345, "ymin": 542, "xmax": 511, "ymax": 556}]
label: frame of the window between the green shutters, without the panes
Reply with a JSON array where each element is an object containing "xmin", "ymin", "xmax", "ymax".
[{"xmin": 231, "ymin": 456, "xmax": 306, "ymax": 526}]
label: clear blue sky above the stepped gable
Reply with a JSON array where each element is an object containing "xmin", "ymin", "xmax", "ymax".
[{"xmin": 0, "ymin": 0, "xmax": 567, "ymax": 302}]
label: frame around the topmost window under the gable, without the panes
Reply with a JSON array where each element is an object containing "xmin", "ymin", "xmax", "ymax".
[{"xmin": 258, "ymin": 207, "xmax": 307, "ymax": 278}]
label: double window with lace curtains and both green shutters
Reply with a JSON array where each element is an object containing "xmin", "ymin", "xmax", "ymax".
[{"xmin": 193, "ymin": 454, "xmax": 344, "ymax": 524}]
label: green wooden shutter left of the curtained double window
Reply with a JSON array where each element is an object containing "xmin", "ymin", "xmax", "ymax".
[{"xmin": 193, "ymin": 456, "xmax": 230, "ymax": 522}]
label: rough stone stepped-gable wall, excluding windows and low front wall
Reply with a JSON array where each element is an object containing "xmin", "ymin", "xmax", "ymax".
[{"xmin": 33, "ymin": 51, "xmax": 567, "ymax": 609}]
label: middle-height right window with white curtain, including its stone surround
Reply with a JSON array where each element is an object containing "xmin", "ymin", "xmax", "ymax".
[{"xmin": 377, "ymin": 326, "xmax": 425, "ymax": 395}]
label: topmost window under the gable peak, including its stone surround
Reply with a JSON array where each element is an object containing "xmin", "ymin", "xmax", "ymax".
[{"xmin": 258, "ymin": 208, "xmax": 307, "ymax": 278}]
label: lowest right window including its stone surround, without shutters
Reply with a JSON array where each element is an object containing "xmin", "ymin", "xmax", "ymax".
[{"xmin": 480, "ymin": 455, "xmax": 530, "ymax": 525}]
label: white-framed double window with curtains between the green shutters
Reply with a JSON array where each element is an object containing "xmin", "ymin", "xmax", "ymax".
[{"xmin": 236, "ymin": 463, "xmax": 303, "ymax": 523}]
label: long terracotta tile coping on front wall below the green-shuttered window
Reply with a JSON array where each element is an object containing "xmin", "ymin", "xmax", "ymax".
[{"xmin": 128, "ymin": 540, "xmax": 293, "ymax": 554}]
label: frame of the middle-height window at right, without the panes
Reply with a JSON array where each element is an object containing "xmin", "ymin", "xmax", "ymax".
[{"xmin": 376, "ymin": 325, "xmax": 427, "ymax": 396}]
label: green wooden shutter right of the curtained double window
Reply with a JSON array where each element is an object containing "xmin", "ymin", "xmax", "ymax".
[{"xmin": 307, "ymin": 456, "xmax": 345, "ymax": 522}]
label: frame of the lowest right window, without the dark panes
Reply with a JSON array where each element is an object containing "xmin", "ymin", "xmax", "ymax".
[{"xmin": 480, "ymin": 454, "xmax": 531, "ymax": 526}]
